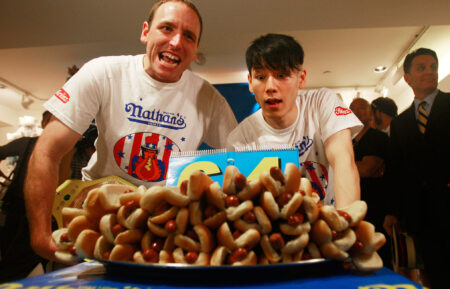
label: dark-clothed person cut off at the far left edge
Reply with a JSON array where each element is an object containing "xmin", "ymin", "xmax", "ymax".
[{"xmin": 0, "ymin": 111, "xmax": 52, "ymax": 283}]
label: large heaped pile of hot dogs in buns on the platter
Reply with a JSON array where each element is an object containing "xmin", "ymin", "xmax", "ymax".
[{"xmin": 53, "ymin": 164, "xmax": 386, "ymax": 271}]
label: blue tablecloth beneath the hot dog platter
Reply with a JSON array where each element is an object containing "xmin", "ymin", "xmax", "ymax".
[{"xmin": 0, "ymin": 262, "xmax": 424, "ymax": 289}]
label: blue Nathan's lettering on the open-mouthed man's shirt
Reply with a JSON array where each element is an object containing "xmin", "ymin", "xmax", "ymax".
[{"xmin": 125, "ymin": 103, "xmax": 186, "ymax": 129}]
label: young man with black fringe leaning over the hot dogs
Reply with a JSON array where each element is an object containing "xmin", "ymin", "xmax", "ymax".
[{"xmin": 228, "ymin": 34, "xmax": 362, "ymax": 208}]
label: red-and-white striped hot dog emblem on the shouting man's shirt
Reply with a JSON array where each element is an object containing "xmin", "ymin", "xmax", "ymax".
[{"xmin": 114, "ymin": 132, "xmax": 180, "ymax": 182}]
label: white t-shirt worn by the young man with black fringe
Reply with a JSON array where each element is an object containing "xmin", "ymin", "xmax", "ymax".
[{"xmin": 228, "ymin": 88, "xmax": 363, "ymax": 204}]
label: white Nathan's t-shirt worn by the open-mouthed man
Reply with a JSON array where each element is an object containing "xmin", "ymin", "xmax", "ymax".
[{"xmin": 44, "ymin": 55, "xmax": 237, "ymax": 187}]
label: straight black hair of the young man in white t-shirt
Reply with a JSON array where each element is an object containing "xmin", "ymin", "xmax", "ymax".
[{"xmin": 245, "ymin": 33, "xmax": 304, "ymax": 74}]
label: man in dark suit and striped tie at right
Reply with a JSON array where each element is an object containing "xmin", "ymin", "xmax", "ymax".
[{"xmin": 384, "ymin": 48, "xmax": 450, "ymax": 289}]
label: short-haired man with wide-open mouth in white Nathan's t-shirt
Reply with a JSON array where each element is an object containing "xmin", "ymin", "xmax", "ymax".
[{"xmin": 25, "ymin": 0, "xmax": 237, "ymax": 261}]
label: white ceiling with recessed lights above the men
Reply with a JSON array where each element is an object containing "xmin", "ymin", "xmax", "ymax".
[{"xmin": 0, "ymin": 0, "xmax": 450, "ymax": 126}]
